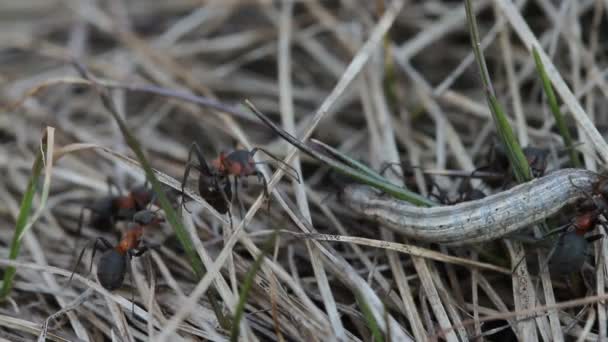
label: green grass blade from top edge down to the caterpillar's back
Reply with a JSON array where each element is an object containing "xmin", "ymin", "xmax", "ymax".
[{"xmin": 465, "ymin": 0, "xmax": 532, "ymax": 183}]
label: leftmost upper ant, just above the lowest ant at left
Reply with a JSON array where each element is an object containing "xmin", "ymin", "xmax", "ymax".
[{"xmin": 77, "ymin": 178, "xmax": 155, "ymax": 236}]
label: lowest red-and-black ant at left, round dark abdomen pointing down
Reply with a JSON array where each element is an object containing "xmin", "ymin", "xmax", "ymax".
[{"xmin": 68, "ymin": 209, "xmax": 164, "ymax": 291}]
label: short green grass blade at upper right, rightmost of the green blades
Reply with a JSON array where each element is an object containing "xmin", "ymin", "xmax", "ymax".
[{"xmin": 532, "ymin": 47, "xmax": 583, "ymax": 167}]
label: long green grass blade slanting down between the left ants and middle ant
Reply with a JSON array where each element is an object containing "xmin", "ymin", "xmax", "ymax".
[{"xmin": 75, "ymin": 63, "xmax": 230, "ymax": 329}]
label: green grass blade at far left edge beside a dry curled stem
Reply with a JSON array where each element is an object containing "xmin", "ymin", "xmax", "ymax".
[{"xmin": 0, "ymin": 136, "xmax": 46, "ymax": 300}]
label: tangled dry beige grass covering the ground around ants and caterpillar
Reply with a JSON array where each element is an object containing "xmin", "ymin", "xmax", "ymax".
[{"xmin": 0, "ymin": 0, "xmax": 608, "ymax": 341}]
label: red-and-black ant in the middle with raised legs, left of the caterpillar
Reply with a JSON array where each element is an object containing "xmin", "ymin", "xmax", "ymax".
[{"xmin": 182, "ymin": 142, "xmax": 300, "ymax": 220}]
